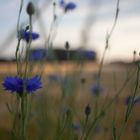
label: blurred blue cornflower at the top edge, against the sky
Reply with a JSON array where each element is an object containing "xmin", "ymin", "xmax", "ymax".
[{"xmin": 60, "ymin": 0, "xmax": 77, "ymax": 12}]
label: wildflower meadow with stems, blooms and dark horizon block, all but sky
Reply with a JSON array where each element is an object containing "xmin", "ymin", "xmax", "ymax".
[{"xmin": 0, "ymin": 0, "xmax": 140, "ymax": 140}]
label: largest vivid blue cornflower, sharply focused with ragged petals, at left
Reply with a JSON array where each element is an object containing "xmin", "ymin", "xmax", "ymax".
[{"xmin": 2, "ymin": 76, "xmax": 42, "ymax": 96}]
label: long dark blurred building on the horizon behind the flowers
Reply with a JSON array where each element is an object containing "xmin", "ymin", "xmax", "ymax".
[{"xmin": 29, "ymin": 48, "xmax": 96, "ymax": 61}]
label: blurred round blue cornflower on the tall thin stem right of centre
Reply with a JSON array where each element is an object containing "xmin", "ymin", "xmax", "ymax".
[{"xmin": 91, "ymin": 84, "xmax": 103, "ymax": 96}]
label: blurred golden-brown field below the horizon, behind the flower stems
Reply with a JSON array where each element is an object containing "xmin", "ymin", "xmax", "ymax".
[{"xmin": 0, "ymin": 62, "xmax": 140, "ymax": 140}]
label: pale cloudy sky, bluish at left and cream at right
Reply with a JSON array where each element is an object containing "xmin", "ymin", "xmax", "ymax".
[{"xmin": 0, "ymin": 0, "xmax": 140, "ymax": 61}]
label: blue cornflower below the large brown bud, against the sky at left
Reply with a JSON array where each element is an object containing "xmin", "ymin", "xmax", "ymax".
[{"xmin": 18, "ymin": 29, "xmax": 39, "ymax": 42}]
